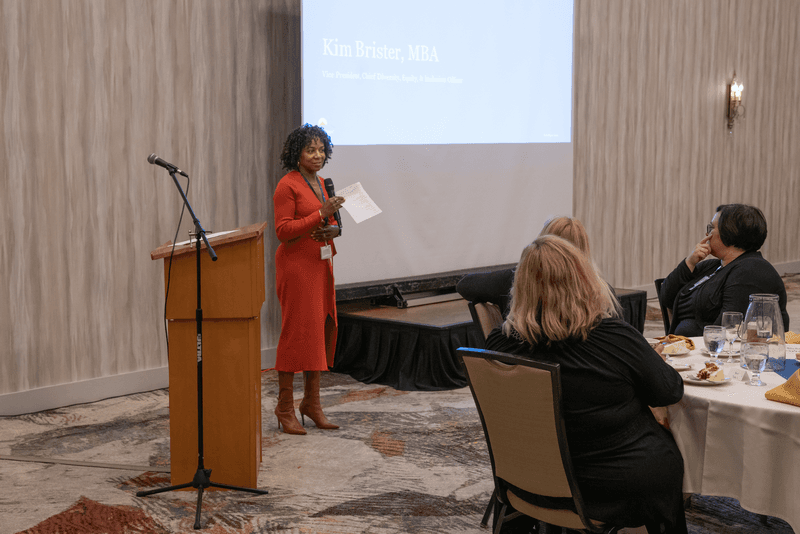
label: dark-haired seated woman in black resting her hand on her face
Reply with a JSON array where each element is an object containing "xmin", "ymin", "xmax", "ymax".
[{"xmin": 659, "ymin": 204, "xmax": 789, "ymax": 337}]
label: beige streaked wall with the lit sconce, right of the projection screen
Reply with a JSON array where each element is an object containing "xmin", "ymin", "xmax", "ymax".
[{"xmin": 573, "ymin": 0, "xmax": 800, "ymax": 287}]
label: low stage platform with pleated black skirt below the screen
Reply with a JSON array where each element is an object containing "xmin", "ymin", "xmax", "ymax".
[{"xmin": 333, "ymin": 289, "xmax": 647, "ymax": 391}]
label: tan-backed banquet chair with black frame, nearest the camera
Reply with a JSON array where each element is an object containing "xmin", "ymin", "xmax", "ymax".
[{"xmin": 458, "ymin": 348, "xmax": 621, "ymax": 534}]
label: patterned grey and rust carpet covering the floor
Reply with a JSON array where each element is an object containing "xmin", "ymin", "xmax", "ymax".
[{"xmin": 0, "ymin": 372, "xmax": 792, "ymax": 534}]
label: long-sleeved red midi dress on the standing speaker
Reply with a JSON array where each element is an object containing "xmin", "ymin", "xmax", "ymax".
[{"xmin": 272, "ymin": 171, "xmax": 337, "ymax": 372}]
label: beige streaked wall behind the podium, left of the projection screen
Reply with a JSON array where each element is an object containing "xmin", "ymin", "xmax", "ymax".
[{"xmin": 0, "ymin": 0, "xmax": 300, "ymax": 394}]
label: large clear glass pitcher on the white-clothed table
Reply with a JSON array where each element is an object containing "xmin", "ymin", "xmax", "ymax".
[{"xmin": 739, "ymin": 293, "xmax": 786, "ymax": 371}]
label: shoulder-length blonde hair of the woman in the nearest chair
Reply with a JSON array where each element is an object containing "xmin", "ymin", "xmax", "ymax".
[{"xmin": 503, "ymin": 235, "xmax": 617, "ymax": 345}]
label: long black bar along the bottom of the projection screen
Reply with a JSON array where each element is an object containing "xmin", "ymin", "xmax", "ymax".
[{"xmin": 336, "ymin": 263, "xmax": 516, "ymax": 302}]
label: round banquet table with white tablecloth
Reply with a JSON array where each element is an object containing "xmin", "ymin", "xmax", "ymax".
[{"xmin": 667, "ymin": 338, "xmax": 800, "ymax": 533}]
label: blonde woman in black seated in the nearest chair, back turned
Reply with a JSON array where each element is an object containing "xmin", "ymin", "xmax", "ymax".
[{"xmin": 486, "ymin": 235, "xmax": 687, "ymax": 534}]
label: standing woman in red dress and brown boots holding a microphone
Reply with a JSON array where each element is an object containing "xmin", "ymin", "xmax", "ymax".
[{"xmin": 273, "ymin": 124, "xmax": 344, "ymax": 434}]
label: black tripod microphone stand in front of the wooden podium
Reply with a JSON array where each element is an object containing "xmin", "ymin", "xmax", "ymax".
[{"xmin": 136, "ymin": 169, "xmax": 269, "ymax": 530}]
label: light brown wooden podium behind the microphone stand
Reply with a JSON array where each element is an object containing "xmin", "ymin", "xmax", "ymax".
[{"xmin": 150, "ymin": 223, "xmax": 267, "ymax": 489}]
